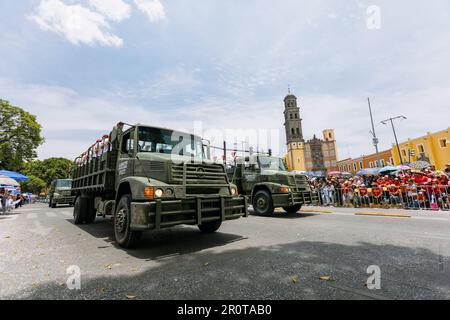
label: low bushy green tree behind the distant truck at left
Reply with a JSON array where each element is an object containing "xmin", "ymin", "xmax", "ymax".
[{"xmin": 22, "ymin": 158, "xmax": 73, "ymax": 187}]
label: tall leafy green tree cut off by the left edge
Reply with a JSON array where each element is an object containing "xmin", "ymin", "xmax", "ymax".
[{"xmin": 0, "ymin": 99, "xmax": 44, "ymax": 171}]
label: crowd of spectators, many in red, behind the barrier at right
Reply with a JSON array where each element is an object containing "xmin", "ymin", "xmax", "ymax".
[{"xmin": 311, "ymin": 165, "xmax": 450, "ymax": 210}]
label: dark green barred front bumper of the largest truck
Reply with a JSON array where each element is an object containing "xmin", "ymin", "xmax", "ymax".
[{"xmin": 130, "ymin": 197, "xmax": 248, "ymax": 231}]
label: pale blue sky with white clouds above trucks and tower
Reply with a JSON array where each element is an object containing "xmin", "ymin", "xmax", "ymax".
[{"xmin": 0, "ymin": 0, "xmax": 450, "ymax": 158}]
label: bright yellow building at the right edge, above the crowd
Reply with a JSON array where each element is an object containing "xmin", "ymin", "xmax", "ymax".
[{"xmin": 391, "ymin": 127, "xmax": 450, "ymax": 170}]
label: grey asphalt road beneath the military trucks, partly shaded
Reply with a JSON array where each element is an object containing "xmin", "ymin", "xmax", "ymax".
[{"xmin": 0, "ymin": 204, "xmax": 450, "ymax": 299}]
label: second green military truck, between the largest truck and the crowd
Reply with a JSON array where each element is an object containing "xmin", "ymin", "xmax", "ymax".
[{"xmin": 227, "ymin": 154, "xmax": 319, "ymax": 216}]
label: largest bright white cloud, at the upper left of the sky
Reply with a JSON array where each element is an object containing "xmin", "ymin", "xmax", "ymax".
[{"xmin": 30, "ymin": 0, "xmax": 123, "ymax": 47}]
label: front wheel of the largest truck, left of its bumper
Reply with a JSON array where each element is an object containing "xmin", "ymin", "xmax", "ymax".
[{"xmin": 114, "ymin": 194, "xmax": 142, "ymax": 248}]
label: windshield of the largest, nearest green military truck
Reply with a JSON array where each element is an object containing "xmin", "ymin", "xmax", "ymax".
[{"xmin": 138, "ymin": 127, "xmax": 204, "ymax": 159}]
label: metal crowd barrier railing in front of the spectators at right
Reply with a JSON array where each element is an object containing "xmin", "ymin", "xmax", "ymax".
[{"xmin": 314, "ymin": 185, "xmax": 450, "ymax": 211}]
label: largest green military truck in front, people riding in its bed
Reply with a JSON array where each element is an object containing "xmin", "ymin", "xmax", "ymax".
[{"xmin": 72, "ymin": 123, "xmax": 248, "ymax": 248}]
